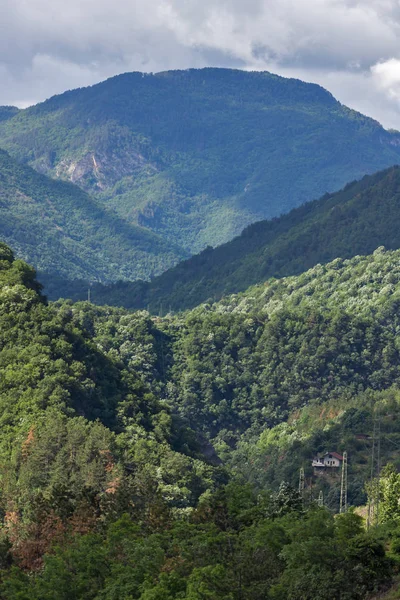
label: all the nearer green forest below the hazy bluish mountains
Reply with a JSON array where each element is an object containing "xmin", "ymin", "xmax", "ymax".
[{"xmin": 0, "ymin": 244, "xmax": 400, "ymax": 600}]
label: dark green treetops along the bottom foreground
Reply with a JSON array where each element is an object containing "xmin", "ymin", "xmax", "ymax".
[{"xmin": 2, "ymin": 500, "xmax": 391, "ymax": 600}]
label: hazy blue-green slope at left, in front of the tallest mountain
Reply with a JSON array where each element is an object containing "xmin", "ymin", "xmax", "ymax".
[{"xmin": 0, "ymin": 150, "xmax": 184, "ymax": 282}]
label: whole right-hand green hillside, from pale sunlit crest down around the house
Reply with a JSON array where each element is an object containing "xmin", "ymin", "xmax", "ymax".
[{"xmin": 67, "ymin": 248, "xmax": 400, "ymax": 508}]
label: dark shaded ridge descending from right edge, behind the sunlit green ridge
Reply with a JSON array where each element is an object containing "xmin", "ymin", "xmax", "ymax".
[{"xmin": 62, "ymin": 167, "xmax": 400, "ymax": 312}]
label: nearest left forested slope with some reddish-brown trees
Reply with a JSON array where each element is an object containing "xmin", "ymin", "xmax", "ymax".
[{"xmin": 0, "ymin": 243, "xmax": 226, "ymax": 572}]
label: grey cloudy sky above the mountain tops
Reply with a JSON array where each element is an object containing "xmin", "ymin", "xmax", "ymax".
[{"xmin": 0, "ymin": 0, "xmax": 400, "ymax": 129}]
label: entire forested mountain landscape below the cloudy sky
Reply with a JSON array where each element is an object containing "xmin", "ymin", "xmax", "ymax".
[{"xmin": 0, "ymin": 68, "xmax": 400, "ymax": 600}]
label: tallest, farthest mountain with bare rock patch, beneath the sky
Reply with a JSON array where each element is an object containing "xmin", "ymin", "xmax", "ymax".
[{"xmin": 0, "ymin": 69, "xmax": 400, "ymax": 253}]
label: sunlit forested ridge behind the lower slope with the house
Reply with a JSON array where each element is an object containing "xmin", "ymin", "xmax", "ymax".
[{"xmin": 52, "ymin": 249, "xmax": 400, "ymax": 466}]
